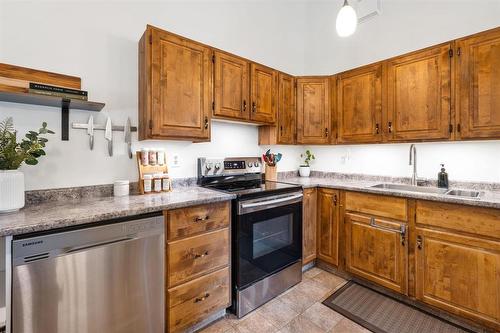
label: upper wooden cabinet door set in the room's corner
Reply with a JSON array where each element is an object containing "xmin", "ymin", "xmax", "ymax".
[{"xmin": 297, "ymin": 78, "xmax": 331, "ymax": 144}]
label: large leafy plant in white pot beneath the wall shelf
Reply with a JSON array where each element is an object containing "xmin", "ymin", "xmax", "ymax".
[{"xmin": 0, "ymin": 117, "xmax": 54, "ymax": 213}]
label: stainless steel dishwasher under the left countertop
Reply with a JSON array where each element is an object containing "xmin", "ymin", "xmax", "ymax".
[{"xmin": 12, "ymin": 216, "xmax": 165, "ymax": 333}]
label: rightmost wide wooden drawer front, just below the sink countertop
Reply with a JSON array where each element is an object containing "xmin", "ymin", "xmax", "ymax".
[{"xmin": 416, "ymin": 201, "xmax": 500, "ymax": 239}]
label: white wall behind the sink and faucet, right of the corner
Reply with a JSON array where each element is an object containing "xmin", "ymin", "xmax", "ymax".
[{"xmin": 276, "ymin": 0, "xmax": 500, "ymax": 182}]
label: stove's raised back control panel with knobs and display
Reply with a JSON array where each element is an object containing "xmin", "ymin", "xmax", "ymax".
[{"xmin": 198, "ymin": 157, "xmax": 262, "ymax": 177}]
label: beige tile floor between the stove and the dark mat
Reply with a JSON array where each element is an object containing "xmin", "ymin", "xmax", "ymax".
[{"xmin": 200, "ymin": 267, "xmax": 370, "ymax": 333}]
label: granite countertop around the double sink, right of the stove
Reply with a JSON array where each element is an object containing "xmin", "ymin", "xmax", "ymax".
[{"xmin": 279, "ymin": 177, "xmax": 500, "ymax": 209}]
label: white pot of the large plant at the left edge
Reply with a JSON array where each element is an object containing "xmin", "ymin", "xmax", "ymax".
[{"xmin": 0, "ymin": 170, "xmax": 24, "ymax": 213}]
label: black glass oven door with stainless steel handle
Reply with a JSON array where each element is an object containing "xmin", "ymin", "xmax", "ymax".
[{"xmin": 233, "ymin": 192, "xmax": 302, "ymax": 290}]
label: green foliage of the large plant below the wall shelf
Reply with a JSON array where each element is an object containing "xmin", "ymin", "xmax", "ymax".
[{"xmin": 0, "ymin": 117, "xmax": 54, "ymax": 170}]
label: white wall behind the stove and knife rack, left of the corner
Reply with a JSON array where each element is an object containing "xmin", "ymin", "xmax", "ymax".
[{"xmin": 0, "ymin": 0, "xmax": 306, "ymax": 189}]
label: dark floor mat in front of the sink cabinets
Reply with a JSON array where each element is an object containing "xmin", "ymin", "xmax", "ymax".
[{"xmin": 323, "ymin": 281, "xmax": 471, "ymax": 333}]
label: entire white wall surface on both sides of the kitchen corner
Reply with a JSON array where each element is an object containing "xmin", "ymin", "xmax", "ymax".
[{"xmin": 0, "ymin": 0, "xmax": 500, "ymax": 189}]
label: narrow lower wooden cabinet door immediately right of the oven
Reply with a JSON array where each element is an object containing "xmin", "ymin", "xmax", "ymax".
[{"xmin": 302, "ymin": 188, "xmax": 318, "ymax": 265}]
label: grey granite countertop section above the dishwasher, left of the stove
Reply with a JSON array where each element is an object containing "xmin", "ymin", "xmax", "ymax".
[{"xmin": 0, "ymin": 186, "xmax": 235, "ymax": 236}]
